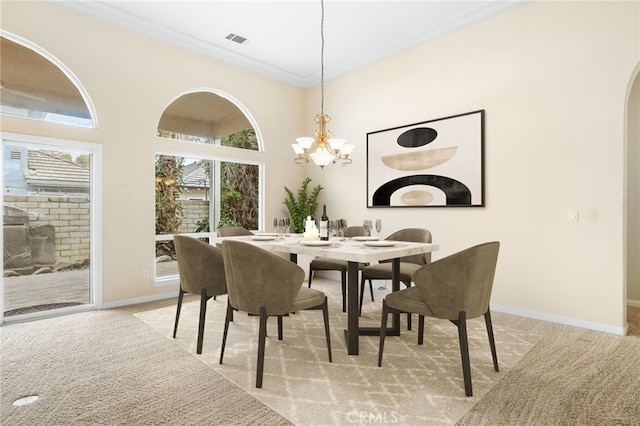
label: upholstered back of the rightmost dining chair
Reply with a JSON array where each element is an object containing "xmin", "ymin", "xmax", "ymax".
[{"xmin": 413, "ymin": 241, "xmax": 500, "ymax": 320}]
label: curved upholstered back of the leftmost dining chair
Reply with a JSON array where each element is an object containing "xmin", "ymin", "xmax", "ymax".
[{"xmin": 173, "ymin": 235, "xmax": 227, "ymax": 296}]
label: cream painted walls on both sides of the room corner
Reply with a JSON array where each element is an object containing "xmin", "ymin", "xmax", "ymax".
[{"xmin": 2, "ymin": 1, "xmax": 640, "ymax": 332}]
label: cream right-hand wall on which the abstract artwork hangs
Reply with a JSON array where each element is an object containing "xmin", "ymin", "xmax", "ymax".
[{"xmin": 307, "ymin": 2, "xmax": 640, "ymax": 332}]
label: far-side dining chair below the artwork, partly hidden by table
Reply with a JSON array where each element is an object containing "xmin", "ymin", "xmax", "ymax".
[{"xmin": 360, "ymin": 228, "xmax": 431, "ymax": 330}]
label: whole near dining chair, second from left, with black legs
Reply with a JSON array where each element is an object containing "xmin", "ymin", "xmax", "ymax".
[{"xmin": 220, "ymin": 240, "xmax": 332, "ymax": 388}]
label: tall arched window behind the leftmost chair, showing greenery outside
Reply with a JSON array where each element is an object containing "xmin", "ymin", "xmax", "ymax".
[{"xmin": 155, "ymin": 91, "xmax": 262, "ymax": 282}]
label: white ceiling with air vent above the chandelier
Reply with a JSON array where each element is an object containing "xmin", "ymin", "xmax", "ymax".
[{"xmin": 55, "ymin": 0, "xmax": 531, "ymax": 87}]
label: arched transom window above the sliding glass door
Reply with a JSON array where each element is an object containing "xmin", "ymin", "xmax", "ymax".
[{"xmin": 0, "ymin": 33, "xmax": 95, "ymax": 127}]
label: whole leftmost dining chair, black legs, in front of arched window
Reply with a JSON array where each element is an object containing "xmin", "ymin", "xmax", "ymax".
[{"xmin": 173, "ymin": 235, "xmax": 227, "ymax": 354}]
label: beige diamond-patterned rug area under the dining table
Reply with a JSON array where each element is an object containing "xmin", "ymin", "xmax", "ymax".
[{"xmin": 136, "ymin": 279, "xmax": 539, "ymax": 426}]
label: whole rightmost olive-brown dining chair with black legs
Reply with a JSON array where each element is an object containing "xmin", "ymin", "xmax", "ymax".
[{"xmin": 378, "ymin": 241, "xmax": 500, "ymax": 396}]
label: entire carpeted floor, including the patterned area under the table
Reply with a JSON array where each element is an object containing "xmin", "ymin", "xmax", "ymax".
[{"xmin": 0, "ymin": 280, "xmax": 640, "ymax": 426}]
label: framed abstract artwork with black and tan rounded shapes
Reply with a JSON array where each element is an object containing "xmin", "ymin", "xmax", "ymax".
[{"xmin": 367, "ymin": 110, "xmax": 484, "ymax": 207}]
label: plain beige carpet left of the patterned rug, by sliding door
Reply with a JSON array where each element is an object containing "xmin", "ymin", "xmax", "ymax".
[{"xmin": 0, "ymin": 310, "xmax": 289, "ymax": 426}]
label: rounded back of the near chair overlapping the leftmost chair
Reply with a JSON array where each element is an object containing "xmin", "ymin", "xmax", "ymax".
[{"xmin": 222, "ymin": 240, "xmax": 305, "ymax": 315}]
